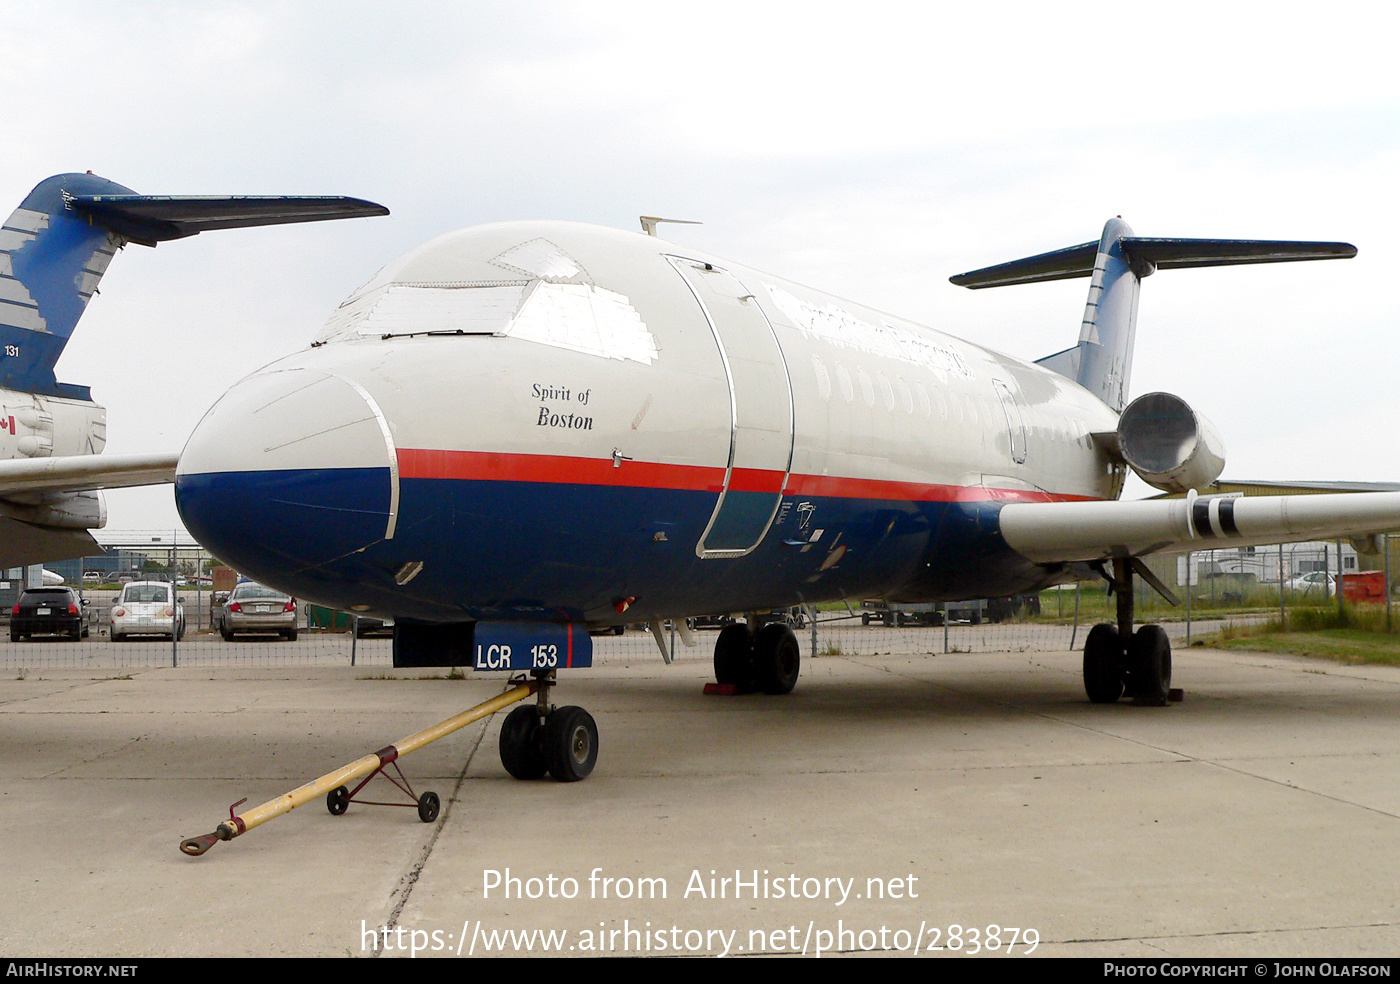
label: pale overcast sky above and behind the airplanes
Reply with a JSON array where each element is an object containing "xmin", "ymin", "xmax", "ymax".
[{"xmin": 0, "ymin": 0, "xmax": 1400, "ymax": 529}]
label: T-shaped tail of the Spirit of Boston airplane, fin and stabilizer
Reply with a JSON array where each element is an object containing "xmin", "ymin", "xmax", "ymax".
[{"xmin": 951, "ymin": 218, "xmax": 1357, "ymax": 410}]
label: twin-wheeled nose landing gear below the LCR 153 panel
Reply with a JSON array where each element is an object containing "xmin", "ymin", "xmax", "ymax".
[{"xmin": 501, "ymin": 670, "xmax": 598, "ymax": 782}]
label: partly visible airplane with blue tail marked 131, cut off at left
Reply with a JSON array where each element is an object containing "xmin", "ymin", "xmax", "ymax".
[{"xmin": 0, "ymin": 172, "xmax": 388, "ymax": 568}]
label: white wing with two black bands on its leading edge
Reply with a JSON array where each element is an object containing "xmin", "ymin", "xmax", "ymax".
[{"xmin": 998, "ymin": 493, "xmax": 1400, "ymax": 564}]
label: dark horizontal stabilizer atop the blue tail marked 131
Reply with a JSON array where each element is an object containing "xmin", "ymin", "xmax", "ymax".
[{"xmin": 69, "ymin": 195, "xmax": 389, "ymax": 246}]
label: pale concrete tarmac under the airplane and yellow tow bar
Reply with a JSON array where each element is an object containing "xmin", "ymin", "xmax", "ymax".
[{"xmin": 0, "ymin": 648, "xmax": 1400, "ymax": 960}]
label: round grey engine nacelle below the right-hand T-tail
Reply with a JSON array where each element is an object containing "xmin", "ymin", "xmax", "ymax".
[{"xmin": 1117, "ymin": 393, "xmax": 1225, "ymax": 493}]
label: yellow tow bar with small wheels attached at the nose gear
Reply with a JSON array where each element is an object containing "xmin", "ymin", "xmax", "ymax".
[{"xmin": 179, "ymin": 675, "xmax": 537, "ymax": 858}]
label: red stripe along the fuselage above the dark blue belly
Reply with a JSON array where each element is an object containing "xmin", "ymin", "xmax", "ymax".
[{"xmin": 399, "ymin": 448, "xmax": 1091, "ymax": 502}]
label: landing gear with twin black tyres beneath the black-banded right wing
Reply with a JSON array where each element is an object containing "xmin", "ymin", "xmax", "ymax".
[{"xmin": 1084, "ymin": 558, "xmax": 1172, "ymax": 707}]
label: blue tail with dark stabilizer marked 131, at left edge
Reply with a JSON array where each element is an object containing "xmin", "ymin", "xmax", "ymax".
[{"xmin": 0, "ymin": 174, "xmax": 388, "ymax": 400}]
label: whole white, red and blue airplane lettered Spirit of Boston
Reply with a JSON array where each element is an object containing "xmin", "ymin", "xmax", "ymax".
[{"xmin": 175, "ymin": 209, "xmax": 1400, "ymax": 781}]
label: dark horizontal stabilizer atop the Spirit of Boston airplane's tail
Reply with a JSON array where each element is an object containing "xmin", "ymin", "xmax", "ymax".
[{"xmin": 949, "ymin": 237, "xmax": 1357, "ymax": 290}]
